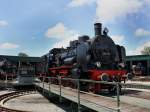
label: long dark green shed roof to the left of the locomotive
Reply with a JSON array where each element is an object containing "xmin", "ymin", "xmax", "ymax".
[{"xmin": 0, "ymin": 55, "xmax": 42, "ymax": 62}]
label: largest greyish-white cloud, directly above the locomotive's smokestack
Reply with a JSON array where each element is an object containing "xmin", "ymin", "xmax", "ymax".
[{"xmin": 96, "ymin": 0, "xmax": 143, "ymax": 22}]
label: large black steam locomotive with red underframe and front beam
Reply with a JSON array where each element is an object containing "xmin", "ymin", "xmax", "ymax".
[{"xmin": 48, "ymin": 23, "xmax": 130, "ymax": 92}]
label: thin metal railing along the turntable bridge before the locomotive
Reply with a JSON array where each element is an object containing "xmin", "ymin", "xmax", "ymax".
[{"xmin": 38, "ymin": 76, "xmax": 120, "ymax": 112}]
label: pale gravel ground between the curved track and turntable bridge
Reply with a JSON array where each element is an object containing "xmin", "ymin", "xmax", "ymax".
[{"xmin": 4, "ymin": 93, "xmax": 66, "ymax": 112}]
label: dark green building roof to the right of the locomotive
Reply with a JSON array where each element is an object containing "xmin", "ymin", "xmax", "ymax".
[{"xmin": 126, "ymin": 55, "xmax": 150, "ymax": 61}]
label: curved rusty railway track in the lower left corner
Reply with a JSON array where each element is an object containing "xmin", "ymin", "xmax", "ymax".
[{"xmin": 0, "ymin": 90, "xmax": 33, "ymax": 112}]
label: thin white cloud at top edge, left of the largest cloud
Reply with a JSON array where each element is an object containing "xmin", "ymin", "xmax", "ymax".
[{"xmin": 68, "ymin": 0, "xmax": 96, "ymax": 7}]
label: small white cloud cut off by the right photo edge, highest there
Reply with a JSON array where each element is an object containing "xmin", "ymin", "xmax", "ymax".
[{"xmin": 135, "ymin": 28, "xmax": 150, "ymax": 37}]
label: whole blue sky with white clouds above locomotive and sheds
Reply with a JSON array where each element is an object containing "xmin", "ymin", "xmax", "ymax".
[{"xmin": 0, "ymin": 0, "xmax": 150, "ymax": 56}]
